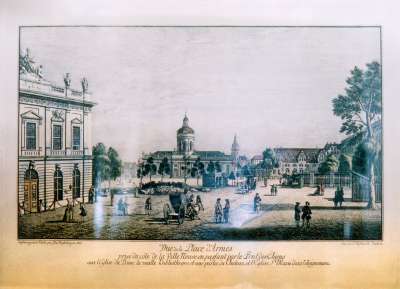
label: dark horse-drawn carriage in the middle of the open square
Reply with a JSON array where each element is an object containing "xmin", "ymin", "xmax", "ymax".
[{"xmin": 163, "ymin": 192, "xmax": 198, "ymax": 225}]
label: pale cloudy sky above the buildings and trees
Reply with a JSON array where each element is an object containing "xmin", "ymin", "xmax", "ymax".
[{"xmin": 20, "ymin": 27, "xmax": 380, "ymax": 161}]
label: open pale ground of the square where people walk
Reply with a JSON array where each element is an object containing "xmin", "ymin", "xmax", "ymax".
[{"xmin": 19, "ymin": 182, "xmax": 382, "ymax": 240}]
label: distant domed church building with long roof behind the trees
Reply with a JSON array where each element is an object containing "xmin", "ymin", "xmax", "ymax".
[{"xmin": 141, "ymin": 114, "xmax": 239, "ymax": 178}]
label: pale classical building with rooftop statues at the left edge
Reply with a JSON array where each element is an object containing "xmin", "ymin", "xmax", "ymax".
[{"xmin": 18, "ymin": 50, "xmax": 95, "ymax": 213}]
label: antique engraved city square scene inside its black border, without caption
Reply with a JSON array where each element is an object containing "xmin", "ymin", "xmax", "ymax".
[{"xmin": 15, "ymin": 26, "xmax": 383, "ymax": 241}]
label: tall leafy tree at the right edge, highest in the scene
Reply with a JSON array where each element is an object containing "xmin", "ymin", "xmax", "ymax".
[{"xmin": 333, "ymin": 61, "xmax": 382, "ymax": 209}]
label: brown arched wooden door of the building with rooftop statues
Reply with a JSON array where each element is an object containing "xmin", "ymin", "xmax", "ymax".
[{"xmin": 24, "ymin": 162, "xmax": 39, "ymax": 213}]
